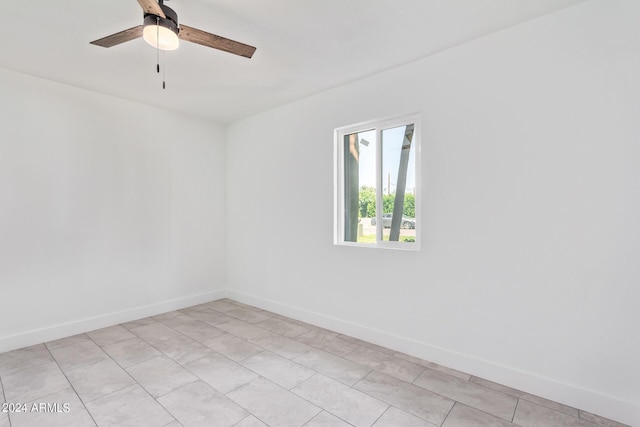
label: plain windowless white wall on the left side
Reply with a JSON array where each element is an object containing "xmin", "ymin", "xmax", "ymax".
[{"xmin": 0, "ymin": 70, "xmax": 226, "ymax": 351}]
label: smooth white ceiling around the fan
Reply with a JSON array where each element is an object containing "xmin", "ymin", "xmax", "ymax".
[{"xmin": 0, "ymin": 0, "xmax": 584, "ymax": 123}]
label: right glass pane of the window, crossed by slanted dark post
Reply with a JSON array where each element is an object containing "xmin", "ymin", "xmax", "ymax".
[{"xmin": 380, "ymin": 124, "xmax": 416, "ymax": 243}]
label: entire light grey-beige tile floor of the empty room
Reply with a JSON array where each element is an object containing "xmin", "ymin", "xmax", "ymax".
[{"xmin": 0, "ymin": 300, "xmax": 622, "ymax": 427}]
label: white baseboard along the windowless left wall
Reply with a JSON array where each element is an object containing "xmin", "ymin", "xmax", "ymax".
[{"xmin": 0, "ymin": 290, "xmax": 227, "ymax": 353}]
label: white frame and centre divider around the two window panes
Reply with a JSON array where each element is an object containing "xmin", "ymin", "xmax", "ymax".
[{"xmin": 333, "ymin": 113, "xmax": 422, "ymax": 251}]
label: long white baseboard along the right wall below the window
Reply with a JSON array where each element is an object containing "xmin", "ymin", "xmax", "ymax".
[{"xmin": 227, "ymin": 290, "xmax": 640, "ymax": 426}]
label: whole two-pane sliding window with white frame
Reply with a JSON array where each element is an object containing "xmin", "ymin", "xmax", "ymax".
[{"xmin": 334, "ymin": 115, "xmax": 420, "ymax": 250}]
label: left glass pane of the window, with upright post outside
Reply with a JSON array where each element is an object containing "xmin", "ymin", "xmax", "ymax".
[{"xmin": 343, "ymin": 130, "xmax": 376, "ymax": 243}]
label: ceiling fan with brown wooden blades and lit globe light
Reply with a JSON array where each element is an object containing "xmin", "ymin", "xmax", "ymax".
[{"xmin": 91, "ymin": 0, "xmax": 256, "ymax": 58}]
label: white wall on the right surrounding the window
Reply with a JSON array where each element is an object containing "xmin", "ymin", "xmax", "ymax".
[{"xmin": 227, "ymin": 0, "xmax": 640, "ymax": 424}]
